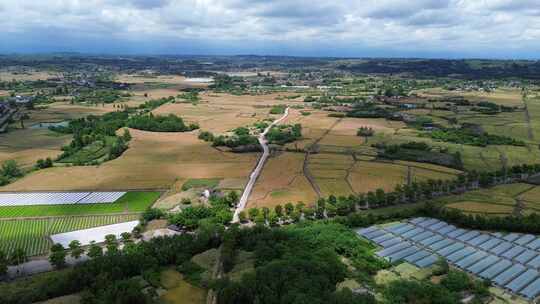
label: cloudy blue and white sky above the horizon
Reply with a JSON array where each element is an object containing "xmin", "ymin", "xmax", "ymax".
[{"xmin": 0, "ymin": 0, "xmax": 540, "ymax": 59}]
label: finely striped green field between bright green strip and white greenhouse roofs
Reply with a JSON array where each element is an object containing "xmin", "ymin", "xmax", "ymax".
[{"xmin": 0, "ymin": 214, "xmax": 139, "ymax": 256}]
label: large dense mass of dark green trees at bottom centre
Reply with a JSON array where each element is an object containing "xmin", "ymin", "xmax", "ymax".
[{"xmin": 215, "ymin": 222, "xmax": 380, "ymax": 304}]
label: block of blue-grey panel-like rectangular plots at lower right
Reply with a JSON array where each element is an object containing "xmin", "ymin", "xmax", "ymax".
[{"xmin": 358, "ymin": 218, "xmax": 540, "ymax": 300}]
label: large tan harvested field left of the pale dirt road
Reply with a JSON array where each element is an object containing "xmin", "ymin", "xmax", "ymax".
[{"xmin": 2, "ymin": 130, "xmax": 257, "ymax": 191}]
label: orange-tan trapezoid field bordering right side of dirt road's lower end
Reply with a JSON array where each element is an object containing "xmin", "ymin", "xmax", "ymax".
[{"xmin": 247, "ymin": 152, "xmax": 317, "ymax": 208}]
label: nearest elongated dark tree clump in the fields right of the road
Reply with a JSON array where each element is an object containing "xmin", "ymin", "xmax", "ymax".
[{"xmin": 373, "ymin": 142, "xmax": 463, "ymax": 170}]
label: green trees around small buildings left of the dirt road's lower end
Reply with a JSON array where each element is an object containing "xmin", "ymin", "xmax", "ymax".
[{"xmin": 169, "ymin": 191, "xmax": 239, "ymax": 230}]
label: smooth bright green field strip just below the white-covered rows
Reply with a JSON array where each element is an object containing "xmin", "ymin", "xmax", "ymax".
[{"xmin": 0, "ymin": 191, "xmax": 161, "ymax": 218}]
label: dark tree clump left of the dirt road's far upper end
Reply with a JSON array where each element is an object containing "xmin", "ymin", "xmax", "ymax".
[{"xmin": 199, "ymin": 127, "xmax": 260, "ymax": 152}]
